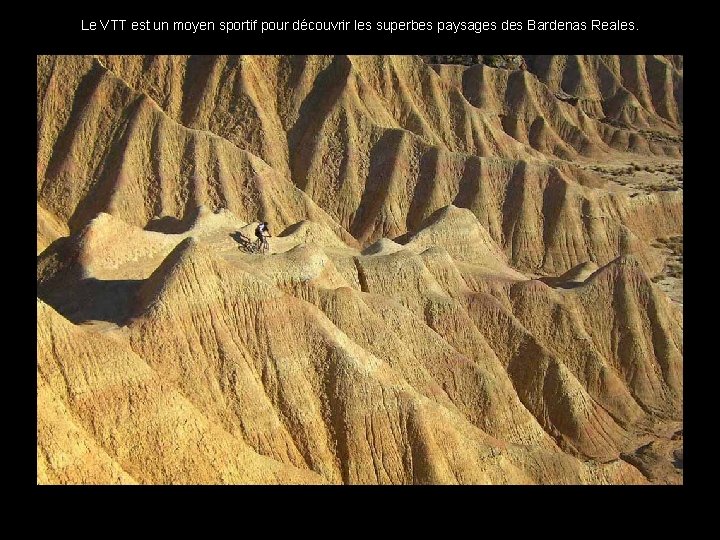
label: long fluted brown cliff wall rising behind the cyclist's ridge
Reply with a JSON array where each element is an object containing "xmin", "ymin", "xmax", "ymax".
[{"xmin": 38, "ymin": 57, "xmax": 682, "ymax": 273}]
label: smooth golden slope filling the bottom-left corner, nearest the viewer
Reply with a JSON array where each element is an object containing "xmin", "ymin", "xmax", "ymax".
[{"xmin": 37, "ymin": 301, "xmax": 322, "ymax": 484}]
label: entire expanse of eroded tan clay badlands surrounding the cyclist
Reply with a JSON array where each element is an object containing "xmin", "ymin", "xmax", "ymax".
[{"xmin": 37, "ymin": 56, "xmax": 683, "ymax": 484}]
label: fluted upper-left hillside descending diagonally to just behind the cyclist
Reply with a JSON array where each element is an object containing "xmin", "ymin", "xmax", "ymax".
[{"xmin": 38, "ymin": 57, "xmax": 358, "ymax": 245}]
